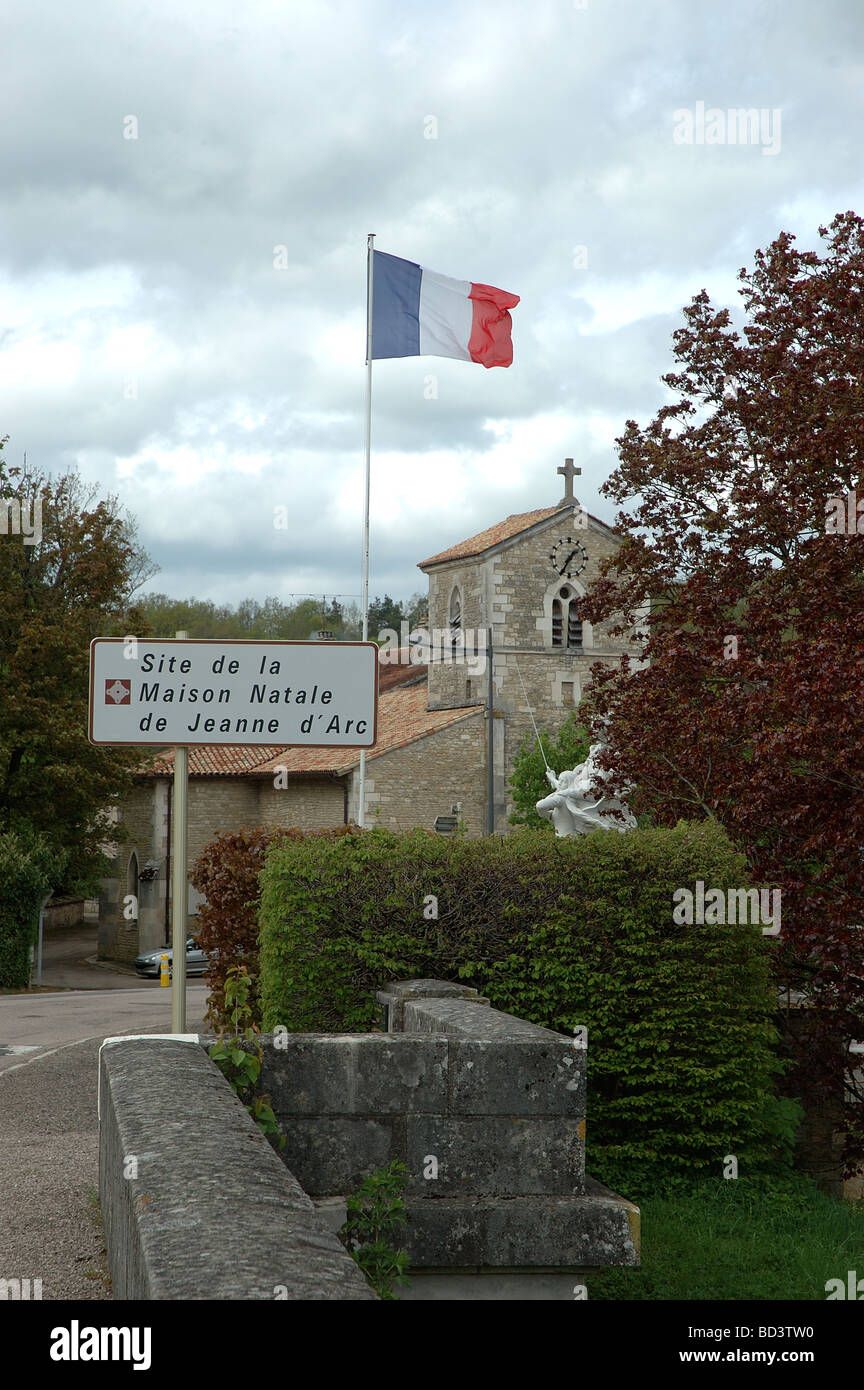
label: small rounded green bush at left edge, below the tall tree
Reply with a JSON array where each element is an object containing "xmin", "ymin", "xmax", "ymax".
[{"xmin": 0, "ymin": 831, "xmax": 63, "ymax": 990}]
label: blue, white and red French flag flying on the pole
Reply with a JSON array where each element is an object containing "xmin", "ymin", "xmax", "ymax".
[{"xmin": 372, "ymin": 252, "xmax": 520, "ymax": 367}]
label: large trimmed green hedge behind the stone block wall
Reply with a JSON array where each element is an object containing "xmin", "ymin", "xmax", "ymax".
[{"xmin": 260, "ymin": 823, "xmax": 793, "ymax": 1176}]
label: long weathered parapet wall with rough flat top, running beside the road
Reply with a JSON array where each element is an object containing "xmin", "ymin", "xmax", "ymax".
[{"xmin": 99, "ymin": 1037, "xmax": 375, "ymax": 1301}]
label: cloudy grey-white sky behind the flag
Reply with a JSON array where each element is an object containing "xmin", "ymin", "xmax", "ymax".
[{"xmin": 0, "ymin": 0, "xmax": 864, "ymax": 603}]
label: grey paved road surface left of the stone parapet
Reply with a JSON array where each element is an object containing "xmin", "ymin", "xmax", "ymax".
[{"xmin": 0, "ymin": 967, "xmax": 207, "ymax": 1300}]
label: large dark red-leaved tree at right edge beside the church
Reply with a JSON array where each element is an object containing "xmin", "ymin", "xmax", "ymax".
[{"xmin": 585, "ymin": 213, "xmax": 864, "ymax": 1165}]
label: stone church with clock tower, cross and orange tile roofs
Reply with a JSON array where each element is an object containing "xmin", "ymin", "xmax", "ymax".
[{"xmin": 100, "ymin": 459, "xmax": 644, "ymax": 959}]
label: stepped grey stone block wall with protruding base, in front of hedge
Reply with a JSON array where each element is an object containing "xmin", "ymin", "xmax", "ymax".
[{"xmin": 260, "ymin": 980, "xmax": 639, "ymax": 1270}]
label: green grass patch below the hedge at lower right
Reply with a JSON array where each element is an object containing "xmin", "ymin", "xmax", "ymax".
[{"xmin": 586, "ymin": 1175, "xmax": 864, "ymax": 1301}]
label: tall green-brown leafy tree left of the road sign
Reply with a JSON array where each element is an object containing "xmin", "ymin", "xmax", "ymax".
[{"xmin": 0, "ymin": 450, "xmax": 153, "ymax": 892}]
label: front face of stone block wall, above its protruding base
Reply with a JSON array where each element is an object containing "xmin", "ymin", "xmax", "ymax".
[{"xmin": 261, "ymin": 1033, "xmax": 585, "ymax": 1197}]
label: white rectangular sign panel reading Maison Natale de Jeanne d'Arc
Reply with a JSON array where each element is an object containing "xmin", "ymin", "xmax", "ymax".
[{"xmin": 89, "ymin": 637, "xmax": 378, "ymax": 748}]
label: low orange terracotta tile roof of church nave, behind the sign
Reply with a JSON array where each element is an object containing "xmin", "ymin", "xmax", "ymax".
[{"xmin": 140, "ymin": 666, "xmax": 483, "ymax": 777}]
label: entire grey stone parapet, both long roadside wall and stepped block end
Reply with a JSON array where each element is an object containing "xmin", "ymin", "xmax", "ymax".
[{"xmin": 99, "ymin": 980, "xmax": 639, "ymax": 1300}]
